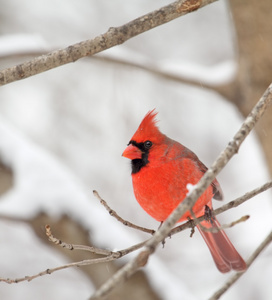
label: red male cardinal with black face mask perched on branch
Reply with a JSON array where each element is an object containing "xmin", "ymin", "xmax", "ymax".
[{"xmin": 122, "ymin": 109, "xmax": 247, "ymax": 273}]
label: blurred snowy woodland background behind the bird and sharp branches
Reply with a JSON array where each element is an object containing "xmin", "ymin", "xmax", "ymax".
[{"xmin": 0, "ymin": 0, "xmax": 272, "ymax": 300}]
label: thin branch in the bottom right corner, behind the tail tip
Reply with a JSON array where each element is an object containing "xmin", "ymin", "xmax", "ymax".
[{"xmin": 209, "ymin": 231, "xmax": 272, "ymax": 300}]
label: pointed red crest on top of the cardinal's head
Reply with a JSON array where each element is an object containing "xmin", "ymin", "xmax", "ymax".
[{"xmin": 131, "ymin": 108, "xmax": 164, "ymax": 143}]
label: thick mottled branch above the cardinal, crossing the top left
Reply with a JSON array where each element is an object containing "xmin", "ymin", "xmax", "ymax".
[{"xmin": 0, "ymin": 0, "xmax": 216, "ymax": 85}]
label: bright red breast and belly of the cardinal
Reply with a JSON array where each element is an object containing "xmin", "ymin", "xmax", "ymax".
[{"xmin": 132, "ymin": 159, "xmax": 212, "ymax": 222}]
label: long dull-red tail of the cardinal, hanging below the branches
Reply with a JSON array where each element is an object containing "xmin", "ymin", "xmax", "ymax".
[{"xmin": 197, "ymin": 217, "xmax": 247, "ymax": 273}]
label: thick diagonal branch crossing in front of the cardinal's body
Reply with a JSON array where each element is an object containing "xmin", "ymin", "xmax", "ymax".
[{"xmin": 90, "ymin": 84, "xmax": 272, "ymax": 300}]
